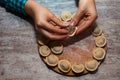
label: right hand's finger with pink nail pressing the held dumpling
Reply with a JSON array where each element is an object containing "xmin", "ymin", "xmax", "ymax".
[{"xmin": 70, "ymin": 9, "xmax": 84, "ymax": 26}]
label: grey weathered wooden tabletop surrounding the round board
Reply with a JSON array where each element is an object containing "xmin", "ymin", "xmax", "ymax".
[{"xmin": 0, "ymin": 0, "xmax": 120, "ymax": 80}]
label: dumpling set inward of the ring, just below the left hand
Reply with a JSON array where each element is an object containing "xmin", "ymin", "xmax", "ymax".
[{"xmin": 50, "ymin": 41, "xmax": 63, "ymax": 54}]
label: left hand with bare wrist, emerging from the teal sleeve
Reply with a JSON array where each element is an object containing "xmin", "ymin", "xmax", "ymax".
[{"xmin": 25, "ymin": 0, "xmax": 68, "ymax": 40}]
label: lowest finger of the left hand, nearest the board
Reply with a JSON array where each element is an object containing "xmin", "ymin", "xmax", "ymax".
[{"xmin": 38, "ymin": 29, "xmax": 67, "ymax": 40}]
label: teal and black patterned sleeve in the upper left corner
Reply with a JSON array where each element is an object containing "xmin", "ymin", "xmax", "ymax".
[{"xmin": 0, "ymin": 0, "xmax": 27, "ymax": 14}]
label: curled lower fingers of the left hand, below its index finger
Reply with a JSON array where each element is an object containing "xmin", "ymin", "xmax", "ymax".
[{"xmin": 36, "ymin": 22, "xmax": 68, "ymax": 40}]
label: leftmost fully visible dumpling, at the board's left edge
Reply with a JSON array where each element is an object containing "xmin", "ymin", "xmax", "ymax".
[{"xmin": 39, "ymin": 45, "xmax": 51, "ymax": 57}]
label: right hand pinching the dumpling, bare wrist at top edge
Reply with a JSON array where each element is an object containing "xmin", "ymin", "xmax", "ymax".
[{"xmin": 71, "ymin": 0, "xmax": 97, "ymax": 34}]
